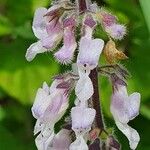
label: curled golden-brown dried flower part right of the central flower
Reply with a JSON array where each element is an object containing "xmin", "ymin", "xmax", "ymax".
[{"xmin": 104, "ymin": 39, "xmax": 128, "ymax": 64}]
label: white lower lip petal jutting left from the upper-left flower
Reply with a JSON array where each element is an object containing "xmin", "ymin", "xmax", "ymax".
[{"xmin": 25, "ymin": 41, "xmax": 47, "ymax": 61}]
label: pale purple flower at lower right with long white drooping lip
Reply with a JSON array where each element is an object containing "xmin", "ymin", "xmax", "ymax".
[{"xmin": 110, "ymin": 84, "xmax": 140, "ymax": 149}]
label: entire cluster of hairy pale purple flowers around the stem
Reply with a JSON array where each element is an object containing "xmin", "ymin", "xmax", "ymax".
[{"xmin": 26, "ymin": 0, "xmax": 140, "ymax": 150}]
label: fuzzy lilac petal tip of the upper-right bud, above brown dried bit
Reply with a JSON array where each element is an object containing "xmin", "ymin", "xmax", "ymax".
[{"xmin": 105, "ymin": 24, "xmax": 126, "ymax": 40}]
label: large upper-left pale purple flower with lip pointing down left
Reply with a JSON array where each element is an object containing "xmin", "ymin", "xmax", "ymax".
[{"xmin": 26, "ymin": 5, "xmax": 63, "ymax": 61}]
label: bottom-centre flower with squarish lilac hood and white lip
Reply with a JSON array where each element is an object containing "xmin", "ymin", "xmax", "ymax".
[{"xmin": 70, "ymin": 106, "xmax": 96, "ymax": 150}]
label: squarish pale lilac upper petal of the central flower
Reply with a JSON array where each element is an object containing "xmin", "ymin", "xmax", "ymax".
[{"xmin": 77, "ymin": 37, "xmax": 104, "ymax": 70}]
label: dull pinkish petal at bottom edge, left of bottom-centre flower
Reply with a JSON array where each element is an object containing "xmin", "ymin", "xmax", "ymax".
[{"xmin": 50, "ymin": 129, "xmax": 71, "ymax": 150}]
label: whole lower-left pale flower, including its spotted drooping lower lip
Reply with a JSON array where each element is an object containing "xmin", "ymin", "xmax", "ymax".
[{"xmin": 32, "ymin": 79, "xmax": 68, "ymax": 150}]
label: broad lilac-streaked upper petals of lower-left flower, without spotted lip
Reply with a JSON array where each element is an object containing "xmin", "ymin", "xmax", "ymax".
[{"xmin": 32, "ymin": 83, "xmax": 68, "ymax": 123}]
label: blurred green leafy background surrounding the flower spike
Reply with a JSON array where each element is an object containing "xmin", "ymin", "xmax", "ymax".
[{"xmin": 0, "ymin": 0, "xmax": 150, "ymax": 150}]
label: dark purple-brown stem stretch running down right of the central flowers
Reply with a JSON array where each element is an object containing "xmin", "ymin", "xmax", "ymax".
[{"xmin": 90, "ymin": 68, "xmax": 104, "ymax": 131}]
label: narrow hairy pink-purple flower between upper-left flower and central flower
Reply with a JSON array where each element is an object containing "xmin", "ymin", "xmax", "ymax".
[{"xmin": 55, "ymin": 16, "xmax": 77, "ymax": 64}]
